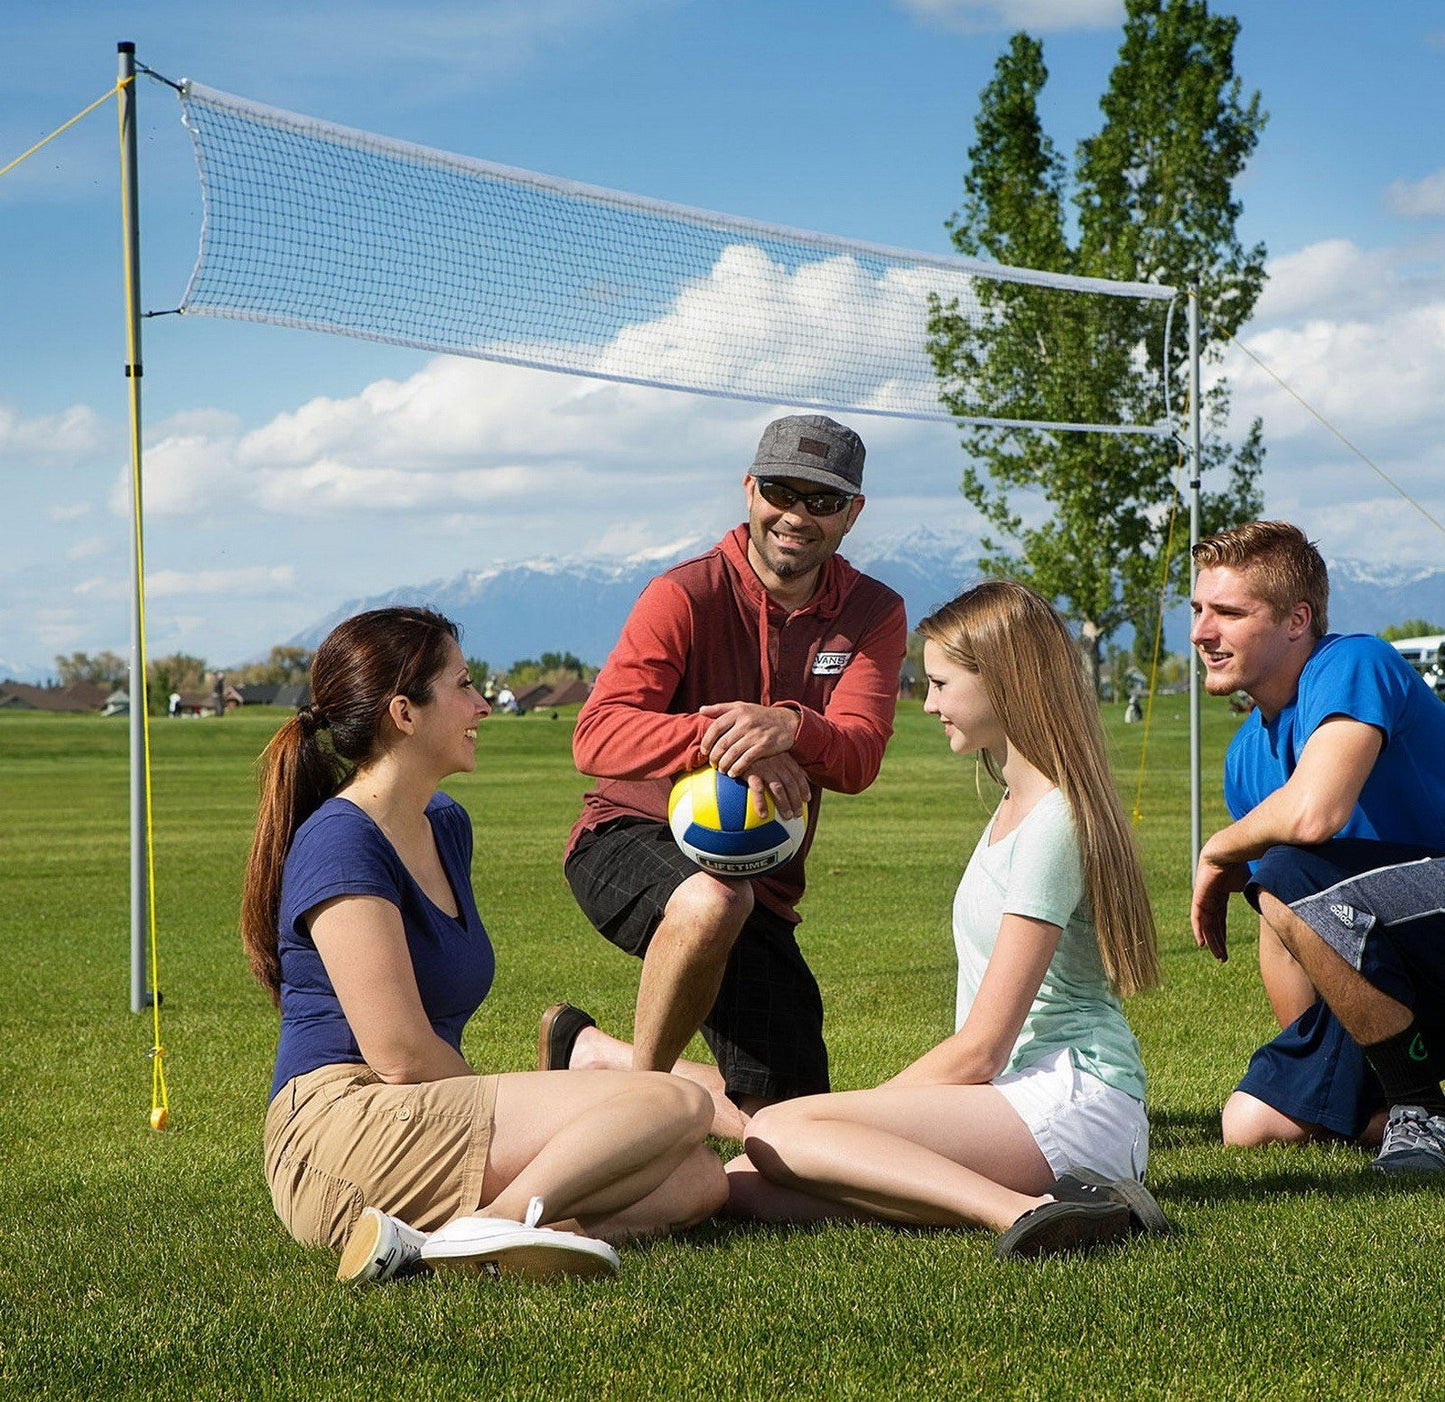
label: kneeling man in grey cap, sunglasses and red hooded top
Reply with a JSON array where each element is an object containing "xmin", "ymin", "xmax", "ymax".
[{"xmin": 539, "ymin": 415, "xmax": 907, "ymax": 1137}]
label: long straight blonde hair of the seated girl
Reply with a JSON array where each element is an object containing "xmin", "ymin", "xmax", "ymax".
[{"xmin": 918, "ymin": 580, "xmax": 1159, "ymax": 996}]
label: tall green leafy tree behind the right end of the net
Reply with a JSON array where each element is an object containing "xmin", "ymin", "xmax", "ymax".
[{"xmin": 929, "ymin": 0, "xmax": 1264, "ymax": 681}]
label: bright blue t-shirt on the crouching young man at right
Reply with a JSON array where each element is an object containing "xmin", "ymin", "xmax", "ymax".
[{"xmin": 1224, "ymin": 633, "xmax": 1445, "ymax": 847}]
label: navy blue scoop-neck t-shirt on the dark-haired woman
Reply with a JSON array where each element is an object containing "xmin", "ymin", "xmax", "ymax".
[{"xmin": 270, "ymin": 794, "xmax": 496, "ymax": 1097}]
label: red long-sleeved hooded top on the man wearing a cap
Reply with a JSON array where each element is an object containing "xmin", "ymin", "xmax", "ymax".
[{"xmin": 568, "ymin": 525, "xmax": 907, "ymax": 921}]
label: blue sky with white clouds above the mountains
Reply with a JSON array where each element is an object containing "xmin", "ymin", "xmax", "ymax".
[{"xmin": 0, "ymin": 0, "xmax": 1445, "ymax": 675}]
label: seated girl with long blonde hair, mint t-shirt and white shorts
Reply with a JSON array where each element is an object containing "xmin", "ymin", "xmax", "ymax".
[{"xmin": 728, "ymin": 581, "xmax": 1168, "ymax": 1256}]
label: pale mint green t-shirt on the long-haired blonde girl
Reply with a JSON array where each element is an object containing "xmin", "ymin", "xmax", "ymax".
[{"xmin": 954, "ymin": 789, "xmax": 1144, "ymax": 1101}]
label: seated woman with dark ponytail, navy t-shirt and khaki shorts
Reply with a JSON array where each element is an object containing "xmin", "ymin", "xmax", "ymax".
[{"xmin": 241, "ymin": 608, "xmax": 725, "ymax": 1281}]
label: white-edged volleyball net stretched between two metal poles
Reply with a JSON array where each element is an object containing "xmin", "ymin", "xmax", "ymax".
[{"xmin": 179, "ymin": 81, "xmax": 1175, "ymax": 434}]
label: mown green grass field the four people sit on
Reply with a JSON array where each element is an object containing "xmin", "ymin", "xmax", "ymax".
[{"xmin": 0, "ymin": 698, "xmax": 1445, "ymax": 1402}]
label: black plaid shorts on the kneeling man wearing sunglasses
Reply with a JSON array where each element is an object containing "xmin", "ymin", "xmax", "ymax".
[{"xmin": 566, "ymin": 818, "xmax": 828, "ymax": 1100}]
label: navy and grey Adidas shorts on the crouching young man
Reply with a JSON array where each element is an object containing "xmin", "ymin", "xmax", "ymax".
[{"xmin": 1238, "ymin": 838, "xmax": 1445, "ymax": 1139}]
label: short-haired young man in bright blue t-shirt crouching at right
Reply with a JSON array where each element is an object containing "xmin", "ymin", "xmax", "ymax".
[{"xmin": 1191, "ymin": 520, "xmax": 1445, "ymax": 1174}]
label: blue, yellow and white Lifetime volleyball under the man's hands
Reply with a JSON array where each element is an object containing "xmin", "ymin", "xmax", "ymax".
[{"xmin": 668, "ymin": 766, "xmax": 808, "ymax": 876}]
